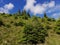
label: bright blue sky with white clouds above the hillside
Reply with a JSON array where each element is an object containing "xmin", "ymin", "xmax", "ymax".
[{"xmin": 0, "ymin": 0, "xmax": 60, "ymax": 18}]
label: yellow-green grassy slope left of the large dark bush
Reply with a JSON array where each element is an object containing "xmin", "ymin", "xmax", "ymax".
[{"xmin": 0, "ymin": 15, "xmax": 24, "ymax": 45}]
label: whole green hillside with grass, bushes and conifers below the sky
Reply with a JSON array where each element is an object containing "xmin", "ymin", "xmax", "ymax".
[{"xmin": 0, "ymin": 11, "xmax": 60, "ymax": 45}]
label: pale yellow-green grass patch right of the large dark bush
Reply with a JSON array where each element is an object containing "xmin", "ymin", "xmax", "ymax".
[{"xmin": 45, "ymin": 31, "xmax": 60, "ymax": 45}]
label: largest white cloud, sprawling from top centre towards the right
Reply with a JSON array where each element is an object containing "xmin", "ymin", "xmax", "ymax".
[{"xmin": 24, "ymin": 0, "xmax": 55, "ymax": 15}]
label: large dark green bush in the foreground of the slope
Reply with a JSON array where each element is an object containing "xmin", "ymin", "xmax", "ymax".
[{"xmin": 23, "ymin": 24, "xmax": 48, "ymax": 44}]
